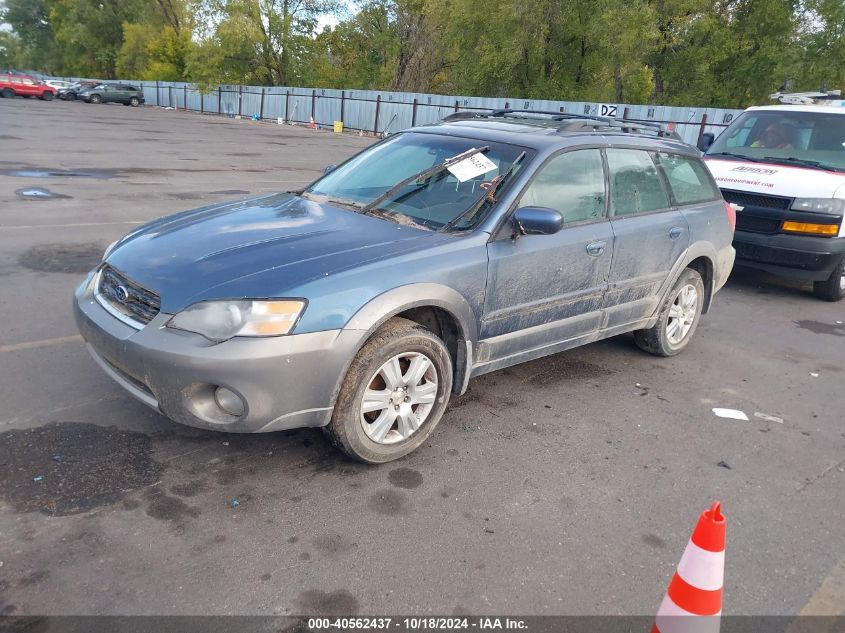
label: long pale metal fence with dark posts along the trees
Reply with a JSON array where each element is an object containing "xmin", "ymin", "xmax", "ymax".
[{"xmin": 120, "ymin": 81, "xmax": 742, "ymax": 144}]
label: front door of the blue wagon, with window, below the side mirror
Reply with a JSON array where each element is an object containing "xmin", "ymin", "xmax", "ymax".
[{"xmin": 481, "ymin": 148, "xmax": 613, "ymax": 360}]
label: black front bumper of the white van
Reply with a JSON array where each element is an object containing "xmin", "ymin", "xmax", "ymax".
[{"xmin": 734, "ymin": 231, "xmax": 845, "ymax": 281}]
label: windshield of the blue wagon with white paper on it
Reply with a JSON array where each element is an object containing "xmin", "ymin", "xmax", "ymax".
[{"xmin": 303, "ymin": 132, "xmax": 528, "ymax": 229}]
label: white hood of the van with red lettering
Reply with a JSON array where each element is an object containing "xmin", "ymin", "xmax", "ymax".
[{"xmin": 704, "ymin": 155, "xmax": 845, "ymax": 198}]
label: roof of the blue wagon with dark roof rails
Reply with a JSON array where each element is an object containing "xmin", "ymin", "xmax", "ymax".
[{"xmin": 406, "ymin": 118, "xmax": 700, "ymax": 156}]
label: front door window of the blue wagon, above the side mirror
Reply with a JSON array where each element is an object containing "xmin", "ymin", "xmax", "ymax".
[{"xmin": 519, "ymin": 149, "xmax": 605, "ymax": 225}]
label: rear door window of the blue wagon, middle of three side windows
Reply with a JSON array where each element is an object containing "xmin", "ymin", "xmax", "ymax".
[{"xmin": 606, "ymin": 149, "xmax": 669, "ymax": 217}]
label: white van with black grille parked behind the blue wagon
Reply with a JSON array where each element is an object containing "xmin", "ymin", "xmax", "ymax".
[{"xmin": 700, "ymin": 94, "xmax": 845, "ymax": 301}]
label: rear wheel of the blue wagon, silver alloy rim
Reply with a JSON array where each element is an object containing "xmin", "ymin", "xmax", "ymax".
[{"xmin": 634, "ymin": 268, "xmax": 704, "ymax": 356}]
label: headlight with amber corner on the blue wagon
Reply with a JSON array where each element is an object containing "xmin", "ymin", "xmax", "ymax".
[{"xmin": 167, "ymin": 300, "xmax": 305, "ymax": 343}]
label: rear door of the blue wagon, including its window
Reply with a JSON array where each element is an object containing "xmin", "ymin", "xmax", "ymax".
[{"xmin": 604, "ymin": 148, "xmax": 689, "ymax": 330}]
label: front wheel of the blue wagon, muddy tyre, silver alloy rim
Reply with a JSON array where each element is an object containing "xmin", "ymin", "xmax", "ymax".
[{"xmin": 325, "ymin": 318, "xmax": 452, "ymax": 464}]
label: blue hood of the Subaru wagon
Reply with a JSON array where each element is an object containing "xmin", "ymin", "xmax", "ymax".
[{"xmin": 106, "ymin": 194, "xmax": 448, "ymax": 313}]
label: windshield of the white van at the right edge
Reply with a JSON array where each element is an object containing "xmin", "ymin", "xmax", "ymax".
[{"xmin": 707, "ymin": 108, "xmax": 845, "ymax": 171}]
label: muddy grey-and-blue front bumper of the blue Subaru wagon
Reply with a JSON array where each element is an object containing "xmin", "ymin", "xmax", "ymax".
[{"xmin": 74, "ymin": 276, "xmax": 364, "ymax": 433}]
